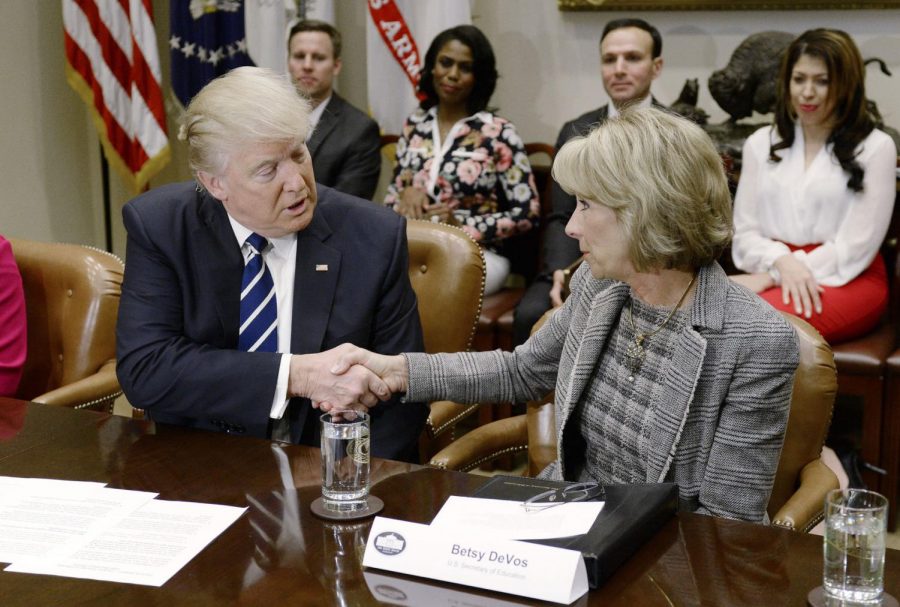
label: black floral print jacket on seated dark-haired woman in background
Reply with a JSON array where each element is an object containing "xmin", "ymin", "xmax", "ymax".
[{"xmin": 385, "ymin": 107, "xmax": 540, "ymax": 244}]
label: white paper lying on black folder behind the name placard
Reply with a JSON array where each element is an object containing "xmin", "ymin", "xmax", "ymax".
[{"xmin": 431, "ymin": 495, "xmax": 603, "ymax": 540}]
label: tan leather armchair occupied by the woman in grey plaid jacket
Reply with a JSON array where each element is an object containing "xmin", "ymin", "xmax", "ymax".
[{"xmin": 430, "ymin": 311, "xmax": 838, "ymax": 531}]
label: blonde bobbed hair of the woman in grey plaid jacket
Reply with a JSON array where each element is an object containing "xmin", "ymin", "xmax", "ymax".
[{"xmin": 553, "ymin": 107, "xmax": 732, "ymax": 272}]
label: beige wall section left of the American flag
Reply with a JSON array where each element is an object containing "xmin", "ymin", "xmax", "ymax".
[{"xmin": 0, "ymin": 0, "xmax": 103, "ymax": 244}]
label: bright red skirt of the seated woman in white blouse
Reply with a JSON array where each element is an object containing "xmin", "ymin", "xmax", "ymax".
[{"xmin": 759, "ymin": 244, "xmax": 888, "ymax": 345}]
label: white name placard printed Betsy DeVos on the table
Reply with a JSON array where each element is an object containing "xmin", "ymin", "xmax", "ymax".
[{"xmin": 363, "ymin": 516, "xmax": 588, "ymax": 604}]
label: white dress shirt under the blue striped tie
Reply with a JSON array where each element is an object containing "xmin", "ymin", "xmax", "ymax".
[{"xmin": 228, "ymin": 215, "xmax": 297, "ymax": 419}]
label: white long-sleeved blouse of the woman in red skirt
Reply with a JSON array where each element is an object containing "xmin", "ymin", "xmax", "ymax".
[{"xmin": 732, "ymin": 125, "xmax": 897, "ymax": 287}]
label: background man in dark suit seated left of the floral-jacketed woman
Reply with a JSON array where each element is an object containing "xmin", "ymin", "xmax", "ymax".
[{"xmin": 288, "ymin": 19, "xmax": 381, "ymax": 200}]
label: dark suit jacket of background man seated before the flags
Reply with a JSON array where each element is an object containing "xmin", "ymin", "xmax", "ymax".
[{"xmin": 307, "ymin": 93, "xmax": 381, "ymax": 200}]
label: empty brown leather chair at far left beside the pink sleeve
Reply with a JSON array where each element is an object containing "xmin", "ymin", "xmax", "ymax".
[{"xmin": 9, "ymin": 238, "xmax": 124, "ymax": 411}]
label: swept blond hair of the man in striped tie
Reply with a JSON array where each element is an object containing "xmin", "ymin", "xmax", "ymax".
[{"xmin": 178, "ymin": 67, "xmax": 310, "ymax": 175}]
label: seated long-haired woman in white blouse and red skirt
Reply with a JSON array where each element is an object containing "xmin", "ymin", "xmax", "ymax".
[{"xmin": 732, "ymin": 29, "xmax": 897, "ymax": 344}]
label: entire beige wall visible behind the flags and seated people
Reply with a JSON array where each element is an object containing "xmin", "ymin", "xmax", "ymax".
[{"xmin": 0, "ymin": 0, "xmax": 900, "ymax": 254}]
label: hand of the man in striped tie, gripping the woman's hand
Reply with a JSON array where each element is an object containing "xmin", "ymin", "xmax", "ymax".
[{"xmin": 288, "ymin": 344, "xmax": 391, "ymax": 411}]
